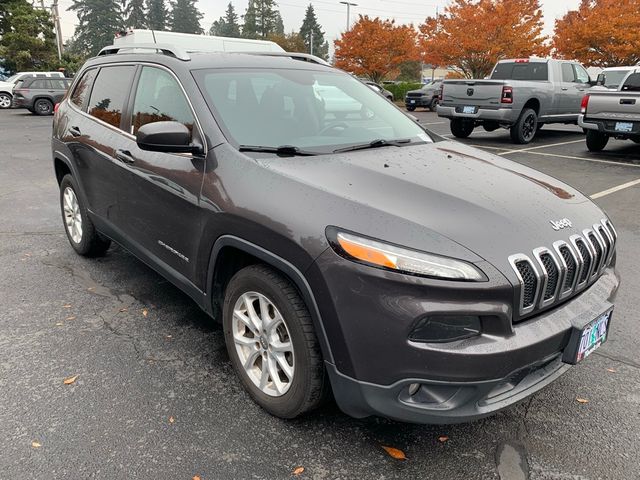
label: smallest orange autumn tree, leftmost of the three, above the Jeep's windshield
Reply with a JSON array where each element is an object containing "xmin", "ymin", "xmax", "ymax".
[{"xmin": 334, "ymin": 15, "xmax": 420, "ymax": 82}]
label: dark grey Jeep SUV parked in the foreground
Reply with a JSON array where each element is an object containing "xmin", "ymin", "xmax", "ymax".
[{"xmin": 52, "ymin": 42, "xmax": 619, "ymax": 423}]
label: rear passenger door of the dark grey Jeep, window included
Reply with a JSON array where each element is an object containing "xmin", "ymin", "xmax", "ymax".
[{"xmin": 65, "ymin": 65, "xmax": 136, "ymax": 229}]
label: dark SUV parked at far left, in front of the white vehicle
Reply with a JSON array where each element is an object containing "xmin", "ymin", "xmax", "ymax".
[{"xmin": 13, "ymin": 77, "xmax": 71, "ymax": 115}]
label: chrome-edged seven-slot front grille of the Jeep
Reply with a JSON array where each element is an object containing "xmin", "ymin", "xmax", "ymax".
[{"xmin": 509, "ymin": 219, "xmax": 617, "ymax": 316}]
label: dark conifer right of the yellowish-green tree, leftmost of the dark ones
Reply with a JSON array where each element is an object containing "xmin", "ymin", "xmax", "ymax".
[{"xmin": 68, "ymin": 0, "xmax": 124, "ymax": 55}]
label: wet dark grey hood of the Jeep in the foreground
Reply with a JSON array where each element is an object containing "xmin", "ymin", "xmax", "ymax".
[{"xmin": 257, "ymin": 141, "xmax": 605, "ymax": 272}]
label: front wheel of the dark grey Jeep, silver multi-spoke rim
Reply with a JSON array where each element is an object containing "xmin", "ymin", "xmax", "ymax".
[{"xmin": 223, "ymin": 265, "xmax": 328, "ymax": 418}]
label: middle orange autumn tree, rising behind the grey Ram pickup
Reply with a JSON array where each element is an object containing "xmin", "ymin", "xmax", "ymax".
[{"xmin": 419, "ymin": 0, "xmax": 550, "ymax": 78}]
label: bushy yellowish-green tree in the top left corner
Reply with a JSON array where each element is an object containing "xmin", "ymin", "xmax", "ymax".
[{"xmin": 0, "ymin": 0, "xmax": 58, "ymax": 72}]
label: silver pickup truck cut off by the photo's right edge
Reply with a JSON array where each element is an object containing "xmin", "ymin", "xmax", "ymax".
[{"xmin": 578, "ymin": 67, "xmax": 640, "ymax": 152}]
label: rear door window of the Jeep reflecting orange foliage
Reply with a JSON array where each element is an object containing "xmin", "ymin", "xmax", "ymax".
[{"xmin": 88, "ymin": 66, "xmax": 135, "ymax": 128}]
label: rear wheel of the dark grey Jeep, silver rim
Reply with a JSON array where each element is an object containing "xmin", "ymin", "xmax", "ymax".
[{"xmin": 60, "ymin": 175, "xmax": 111, "ymax": 257}]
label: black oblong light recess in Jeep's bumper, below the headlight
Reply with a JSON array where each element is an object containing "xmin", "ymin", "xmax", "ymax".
[{"xmin": 409, "ymin": 315, "xmax": 482, "ymax": 343}]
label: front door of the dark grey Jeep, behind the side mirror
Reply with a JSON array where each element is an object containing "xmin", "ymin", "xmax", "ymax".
[{"xmin": 115, "ymin": 65, "xmax": 205, "ymax": 282}]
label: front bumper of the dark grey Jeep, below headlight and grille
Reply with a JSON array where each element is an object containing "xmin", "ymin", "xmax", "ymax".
[{"xmin": 310, "ymin": 250, "xmax": 619, "ymax": 423}]
